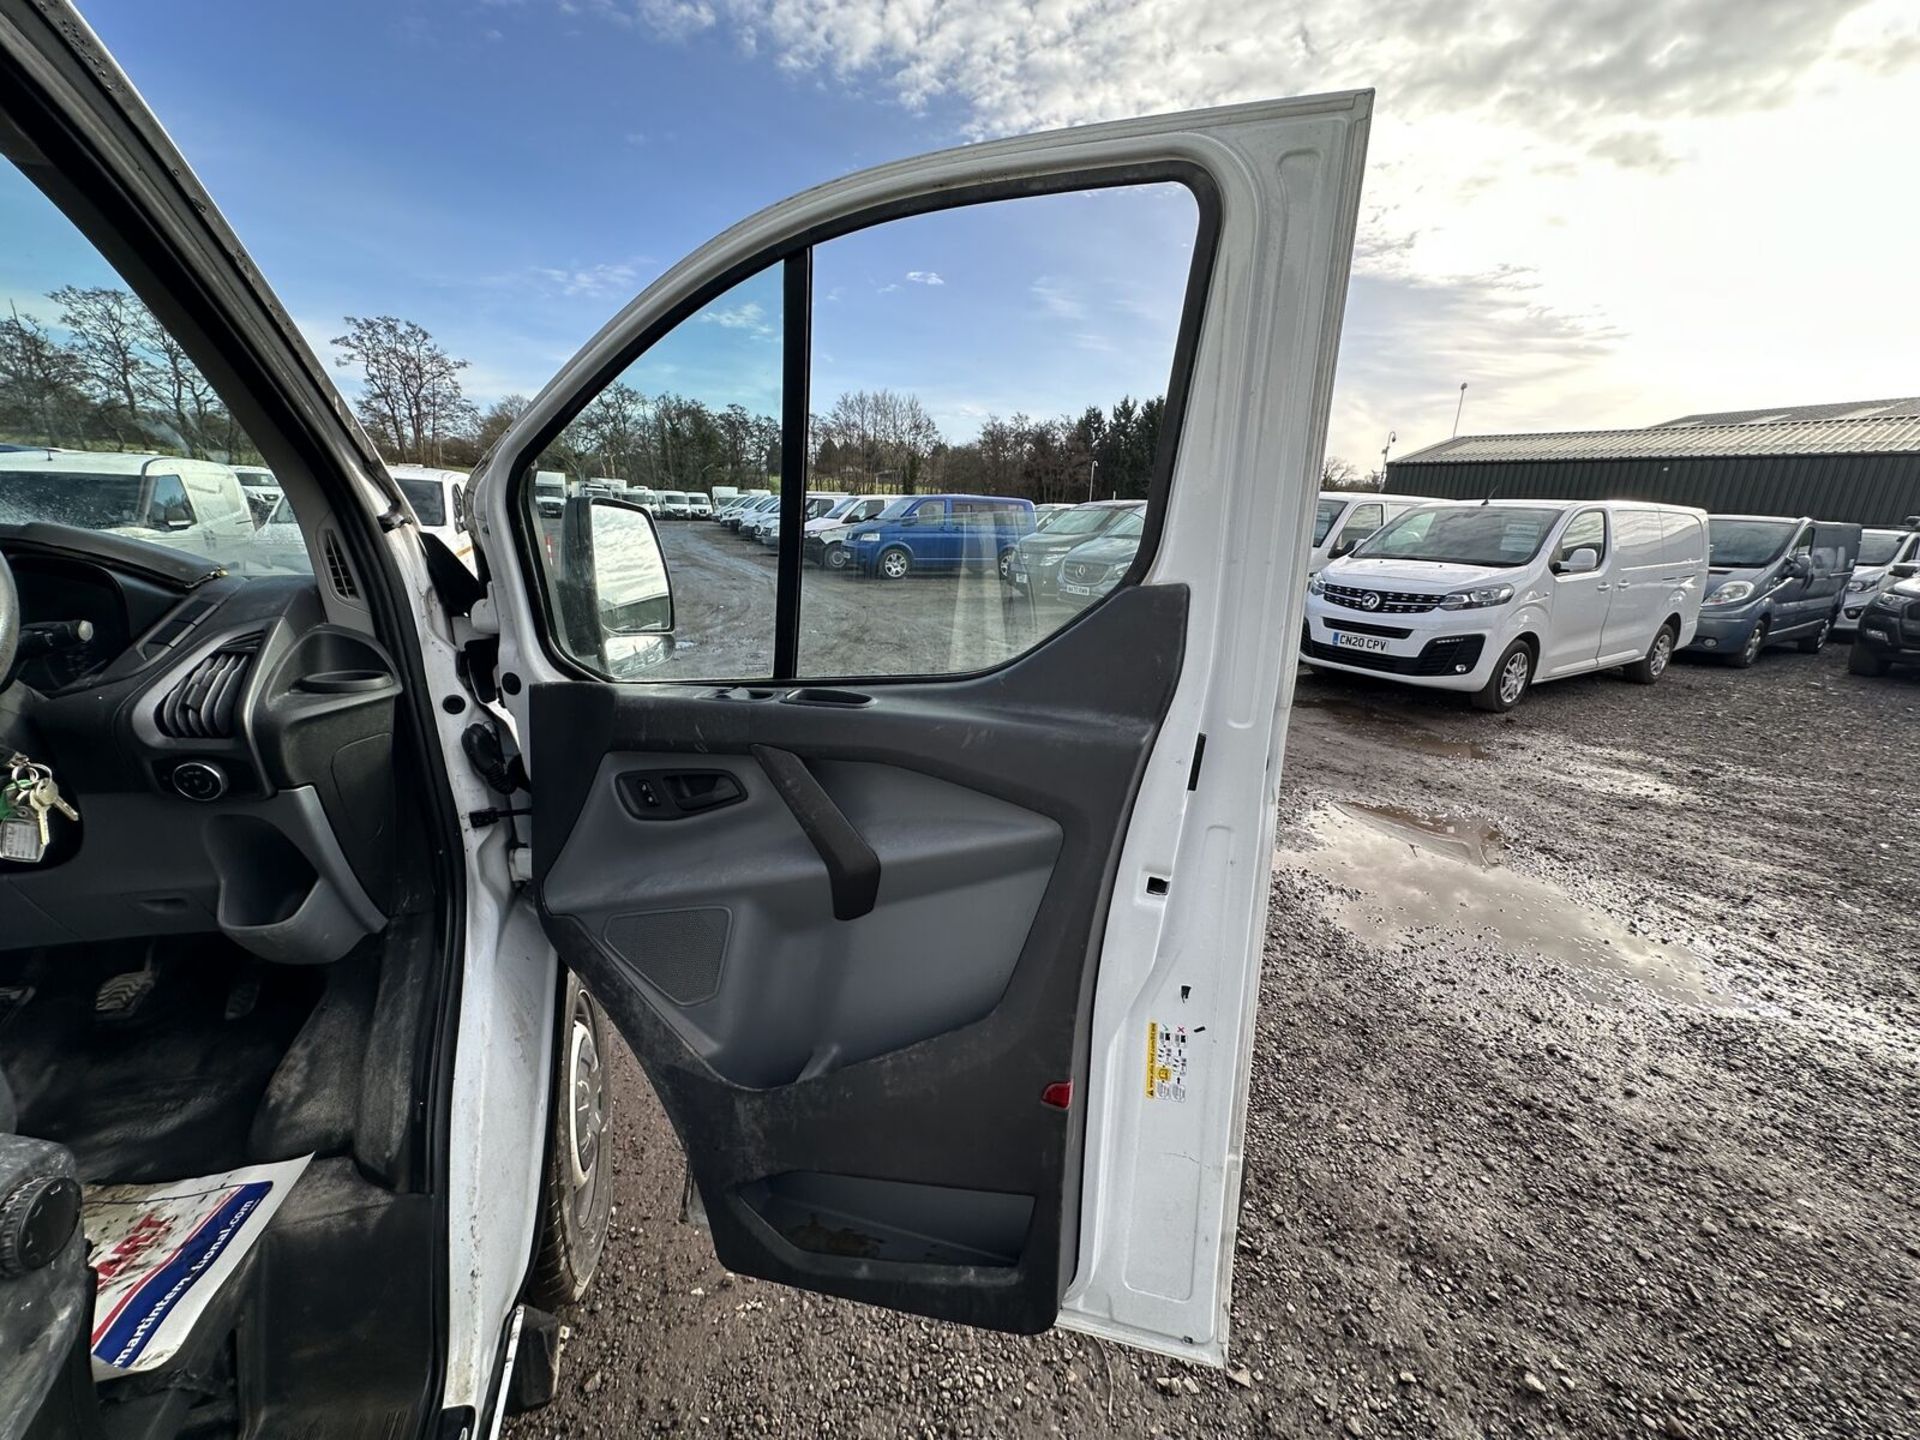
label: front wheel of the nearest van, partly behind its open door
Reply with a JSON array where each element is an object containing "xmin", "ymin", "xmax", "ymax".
[{"xmin": 526, "ymin": 975, "xmax": 612, "ymax": 1311}]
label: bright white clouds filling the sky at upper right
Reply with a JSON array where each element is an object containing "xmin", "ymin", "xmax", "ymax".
[{"xmin": 583, "ymin": 0, "xmax": 1920, "ymax": 459}]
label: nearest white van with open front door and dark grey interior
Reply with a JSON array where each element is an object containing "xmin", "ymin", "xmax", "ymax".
[{"xmin": 0, "ymin": 14, "xmax": 1371, "ymax": 1440}]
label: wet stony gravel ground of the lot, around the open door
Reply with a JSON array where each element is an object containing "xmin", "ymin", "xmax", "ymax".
[{"xmin": 509, "ymin": 625, "xmax": 1920, "ymax": 1436}]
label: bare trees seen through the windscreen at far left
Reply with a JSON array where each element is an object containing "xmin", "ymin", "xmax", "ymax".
[{"xmin": 0, "ymin": 284, "xmax": 259, "ymax": 461}]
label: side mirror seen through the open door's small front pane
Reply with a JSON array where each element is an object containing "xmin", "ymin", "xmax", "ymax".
[{"xmin": 555, "ymin": 495, "xmax": 674, "ymax": 680}]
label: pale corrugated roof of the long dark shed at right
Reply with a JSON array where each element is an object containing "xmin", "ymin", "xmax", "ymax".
[{"xmin": 1394, "ymin": 415, "xmax": 1920, "ymax": 465}]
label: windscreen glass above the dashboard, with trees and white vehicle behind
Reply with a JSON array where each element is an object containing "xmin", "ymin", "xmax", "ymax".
[{"xmin": 0, "ymin": 152, "xmax": 299, "ymax": 572}]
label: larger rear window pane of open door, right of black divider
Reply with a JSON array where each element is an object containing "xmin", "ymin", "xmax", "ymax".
[{"xmin": 799, "ymin": 184, "xmax": 1198, "ymax": 678}]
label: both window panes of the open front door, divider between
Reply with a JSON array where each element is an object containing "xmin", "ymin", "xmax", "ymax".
[{"xmin": 524, "ymin": 184, "xmax": 1200, "ymax": 682}]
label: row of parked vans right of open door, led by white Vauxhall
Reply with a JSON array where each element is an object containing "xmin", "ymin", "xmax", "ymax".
[{"xmin": 1302, "ymin": 501, "xmax": 1896, "ymax": 710}]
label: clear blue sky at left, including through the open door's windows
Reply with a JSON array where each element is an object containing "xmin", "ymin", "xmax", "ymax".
[{"xmin": 48, "ymin": 0, "xmax": 1194, "ymax": 440}]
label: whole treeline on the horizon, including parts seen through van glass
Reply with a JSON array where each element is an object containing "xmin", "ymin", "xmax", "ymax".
[{"xmin": 0, "ymin": 286, "xmax": 1165, "ymax": 503}]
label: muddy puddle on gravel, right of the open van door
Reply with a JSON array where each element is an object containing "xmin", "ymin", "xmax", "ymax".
[{"xmin": 1279, "ymin": 803, "xmax": 1747, "ymax": 1010}]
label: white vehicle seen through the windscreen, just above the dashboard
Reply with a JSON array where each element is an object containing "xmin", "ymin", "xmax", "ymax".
[{"xmin": 0, "ymin": 449, "xmax": 257, "ymax": 555}]
